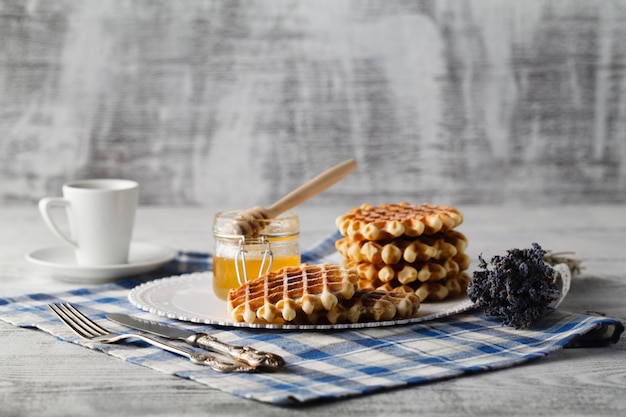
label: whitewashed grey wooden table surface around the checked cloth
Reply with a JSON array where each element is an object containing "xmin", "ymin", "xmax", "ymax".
[{"xmin": 0, "ymin": 205, "xmax": 626, "ymax": 417}]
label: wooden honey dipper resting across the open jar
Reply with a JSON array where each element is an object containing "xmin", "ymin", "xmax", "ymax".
[{"xmin": 233, "ymin": 159, "xmax": 357, "ymax": 237}]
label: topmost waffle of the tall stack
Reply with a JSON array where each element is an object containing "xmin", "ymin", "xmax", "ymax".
[{"xmin": 335, "ymin": 203, "xmax": 463, "ymax": 241}]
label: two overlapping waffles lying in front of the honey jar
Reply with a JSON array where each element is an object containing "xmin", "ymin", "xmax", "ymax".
[{"xmin": 228, "ymin": 263, "xmax": 420, "ymax": 324}]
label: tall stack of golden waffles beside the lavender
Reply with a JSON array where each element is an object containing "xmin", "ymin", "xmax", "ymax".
[{"xmin": 335, "ymin": 203, "xmax": 470, "ymax": 301}]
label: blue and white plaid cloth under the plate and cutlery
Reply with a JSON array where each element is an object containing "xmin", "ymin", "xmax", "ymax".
[{"xmin": 0, "ymin": 232, "xmax": 623, "ymax": 405}]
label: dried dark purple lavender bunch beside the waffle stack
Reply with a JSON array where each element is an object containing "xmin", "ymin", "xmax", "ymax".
[{"xmin": 468, "ymin": 243, "xmax": 560, "ymax": 329}]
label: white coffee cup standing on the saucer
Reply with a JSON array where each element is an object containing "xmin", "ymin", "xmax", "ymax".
[{"xmin": 39, "ymin": 179, "xmax": 139, "ymax": 266}]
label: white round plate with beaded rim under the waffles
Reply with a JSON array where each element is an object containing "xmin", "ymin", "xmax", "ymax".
[{"xmin": 128, "ymin": 272, "xmax": 473, "ymax": 330}]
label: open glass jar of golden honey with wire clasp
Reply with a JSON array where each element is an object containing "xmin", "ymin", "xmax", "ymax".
[{"xmin": 213, "ymin": 210, "xmax": 300, "ymax": 300}]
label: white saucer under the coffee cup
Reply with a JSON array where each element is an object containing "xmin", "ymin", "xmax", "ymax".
[{"xmin": 26, "ymin": 242, "xmax": 176, "ymax": 284}]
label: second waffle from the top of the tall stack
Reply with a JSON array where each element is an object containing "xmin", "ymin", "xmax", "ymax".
[{"xmin": 335, "ymin": 230, "xmax": 467, "ymax": 265}]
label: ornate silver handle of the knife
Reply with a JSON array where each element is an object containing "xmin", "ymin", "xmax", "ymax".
[{"xmin": 187, "ymin": 333, "xmax": 285, "ymax": 371}]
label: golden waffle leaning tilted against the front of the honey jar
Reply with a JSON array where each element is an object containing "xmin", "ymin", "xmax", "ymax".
[{"xmin": 227, "ymin": 264, "xmax": 357, "ymax": 323}]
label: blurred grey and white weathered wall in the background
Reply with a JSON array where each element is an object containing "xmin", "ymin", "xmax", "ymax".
[{"xmin": 0, "ymin": 0, "xmax": 626, "ymax": 207}]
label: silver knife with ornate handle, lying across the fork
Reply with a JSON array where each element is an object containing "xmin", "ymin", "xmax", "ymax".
[{"xmin": 106, "ymin": 313, "xmax": 285, "ymax": 371}]
